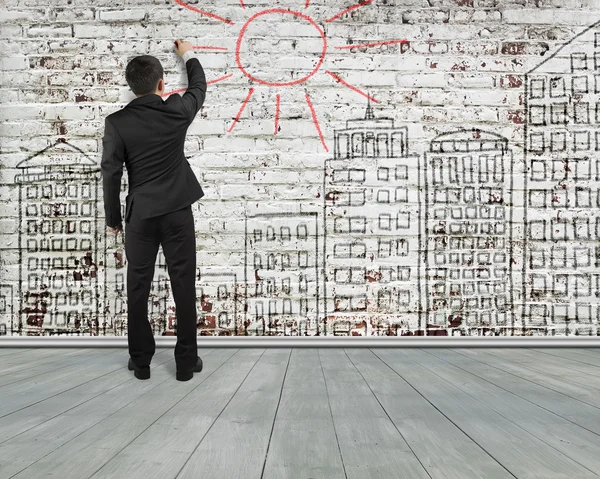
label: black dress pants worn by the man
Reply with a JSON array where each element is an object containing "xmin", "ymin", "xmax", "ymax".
[{"xmin": 125, "ymin": 205, "xmax": 198, "ymax": 370}]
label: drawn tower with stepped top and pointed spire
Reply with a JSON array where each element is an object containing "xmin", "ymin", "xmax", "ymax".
[{"xmin": 324, "ymin": 104, "xmax": 420, "ymax": 335}]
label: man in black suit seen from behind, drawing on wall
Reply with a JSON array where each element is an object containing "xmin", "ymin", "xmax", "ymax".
[{"xmin": 101, "ymin": 40, "xmax": 206, "ymax": 381}]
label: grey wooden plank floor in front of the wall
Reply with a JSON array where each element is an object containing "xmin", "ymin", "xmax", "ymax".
[{"xmin": 0, "ymin": 348, "xmax": 600, "ymax": 479}]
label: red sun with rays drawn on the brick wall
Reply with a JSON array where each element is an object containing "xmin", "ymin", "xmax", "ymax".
[{"xmin": 163, "ymin": 0, "xmax": 407, "ymax": 152}]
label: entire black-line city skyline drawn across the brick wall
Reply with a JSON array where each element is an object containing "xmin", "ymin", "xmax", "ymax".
[{"xmin": 0, "ymin": 23, "xmax": 600, "ymax": 336}]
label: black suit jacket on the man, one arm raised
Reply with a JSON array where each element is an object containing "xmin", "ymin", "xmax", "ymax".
[{"xmin": 101, "ymin": 58, "xmax": 206, "ymax": 227}]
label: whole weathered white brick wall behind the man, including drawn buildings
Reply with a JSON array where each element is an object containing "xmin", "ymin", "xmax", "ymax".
[{"xmin": 0, "ymin": 0, "xmax": 600, "ymax": 336}]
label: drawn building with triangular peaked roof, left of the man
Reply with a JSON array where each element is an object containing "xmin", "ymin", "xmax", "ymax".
[{"xmin": 15, "ymin": 141, "xmax": 104, "ymax": 335}]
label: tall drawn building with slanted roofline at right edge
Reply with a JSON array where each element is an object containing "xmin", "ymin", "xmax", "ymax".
[{"xmin": 523, "ymin": 23, "xmax": 600, "ymax": 335}]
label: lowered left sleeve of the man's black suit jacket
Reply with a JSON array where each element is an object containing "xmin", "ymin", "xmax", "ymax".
[{"xmin": 100, "ymin": 117, "xmax": 125, "ymax": 228}]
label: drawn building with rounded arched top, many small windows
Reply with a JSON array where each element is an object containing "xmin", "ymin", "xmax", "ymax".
[{"xmin": 424, "ymin": 130, "xmax": 513, "ymax": 334}]
